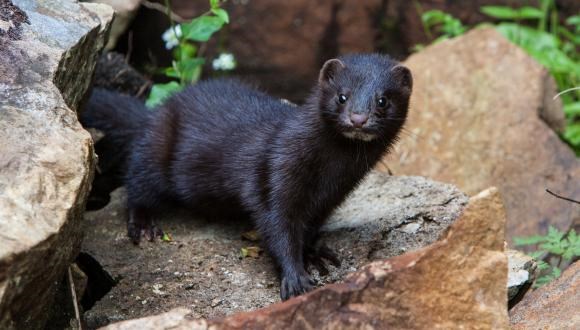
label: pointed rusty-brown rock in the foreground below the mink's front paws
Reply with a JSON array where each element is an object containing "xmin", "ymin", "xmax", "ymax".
[{"xmin": 104, "ymin": 188, "xmax": 509, "ymax": 330}]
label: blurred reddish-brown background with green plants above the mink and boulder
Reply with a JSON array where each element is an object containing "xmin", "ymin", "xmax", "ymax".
[{"xmin": 116, "ymin": 0, "xmax": 580, "ymax": 155}]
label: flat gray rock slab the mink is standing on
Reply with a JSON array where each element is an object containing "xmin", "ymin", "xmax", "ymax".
[{"xmin": 83, "ymin": 173, "xmax": 468, "ymax": 327}]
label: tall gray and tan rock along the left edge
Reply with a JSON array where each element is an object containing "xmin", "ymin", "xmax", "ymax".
[{"xmin": 0, "ymin": 0, "xmax": 112, "ymax": 329}]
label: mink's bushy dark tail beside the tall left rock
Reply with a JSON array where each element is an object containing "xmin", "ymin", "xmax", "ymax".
[{"xmin": 80, "ymin": 88, "xmax": 152, "ymax": 210}]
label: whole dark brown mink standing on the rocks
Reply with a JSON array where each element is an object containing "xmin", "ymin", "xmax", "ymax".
[{"xmin": 82, "ymin": 54, "xmax": 412, "ymax": 300}]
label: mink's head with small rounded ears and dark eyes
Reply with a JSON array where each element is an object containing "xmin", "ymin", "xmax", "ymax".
[{"xmin": 318, "ymin": 54, "xmax": 413, "ymax": 142}]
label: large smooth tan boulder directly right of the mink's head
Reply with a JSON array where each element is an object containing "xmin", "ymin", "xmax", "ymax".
[{"xmin": 381, "ymin": 29, "xmax": 580, "ymax": 245}]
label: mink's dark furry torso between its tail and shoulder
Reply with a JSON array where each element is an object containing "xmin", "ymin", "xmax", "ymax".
[{"xmin": 126, "ymin": 79, "xmax": 298, "ymax": 216}]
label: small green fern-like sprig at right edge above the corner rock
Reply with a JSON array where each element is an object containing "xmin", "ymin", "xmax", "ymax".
[{"xmin": 514, "ymin": 226, "xmax": 580, "ymax": 287}]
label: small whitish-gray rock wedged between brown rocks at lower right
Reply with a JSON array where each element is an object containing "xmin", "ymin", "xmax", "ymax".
[{"xmin": 505, "ymin": 250, "xmax": 538, "ymax": 305}]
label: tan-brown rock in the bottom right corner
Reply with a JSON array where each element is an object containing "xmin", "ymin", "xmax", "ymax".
[{"xmin": 510, "ymin": 262, "xmax": 580, "ymax": 330}]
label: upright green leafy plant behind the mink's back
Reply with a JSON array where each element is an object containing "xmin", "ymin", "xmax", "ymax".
[{"xmin": 146, "ymin": 0, "xmax": 232, "ymax": 107}]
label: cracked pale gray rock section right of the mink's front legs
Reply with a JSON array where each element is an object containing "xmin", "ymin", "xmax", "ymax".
[{"xmin": 323, "ymin": 172, "xmax": 468, "ymax": 266}]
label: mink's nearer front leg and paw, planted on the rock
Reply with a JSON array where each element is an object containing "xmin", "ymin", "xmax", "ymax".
[{"xmin": 256, "ymin": 212, "xmax": 314, "ymax": 300}]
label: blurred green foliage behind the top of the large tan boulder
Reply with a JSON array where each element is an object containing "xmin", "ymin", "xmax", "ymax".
[{"xmin": 415, "ymin": 0, "xmax": 580, "ymax": 156}]
